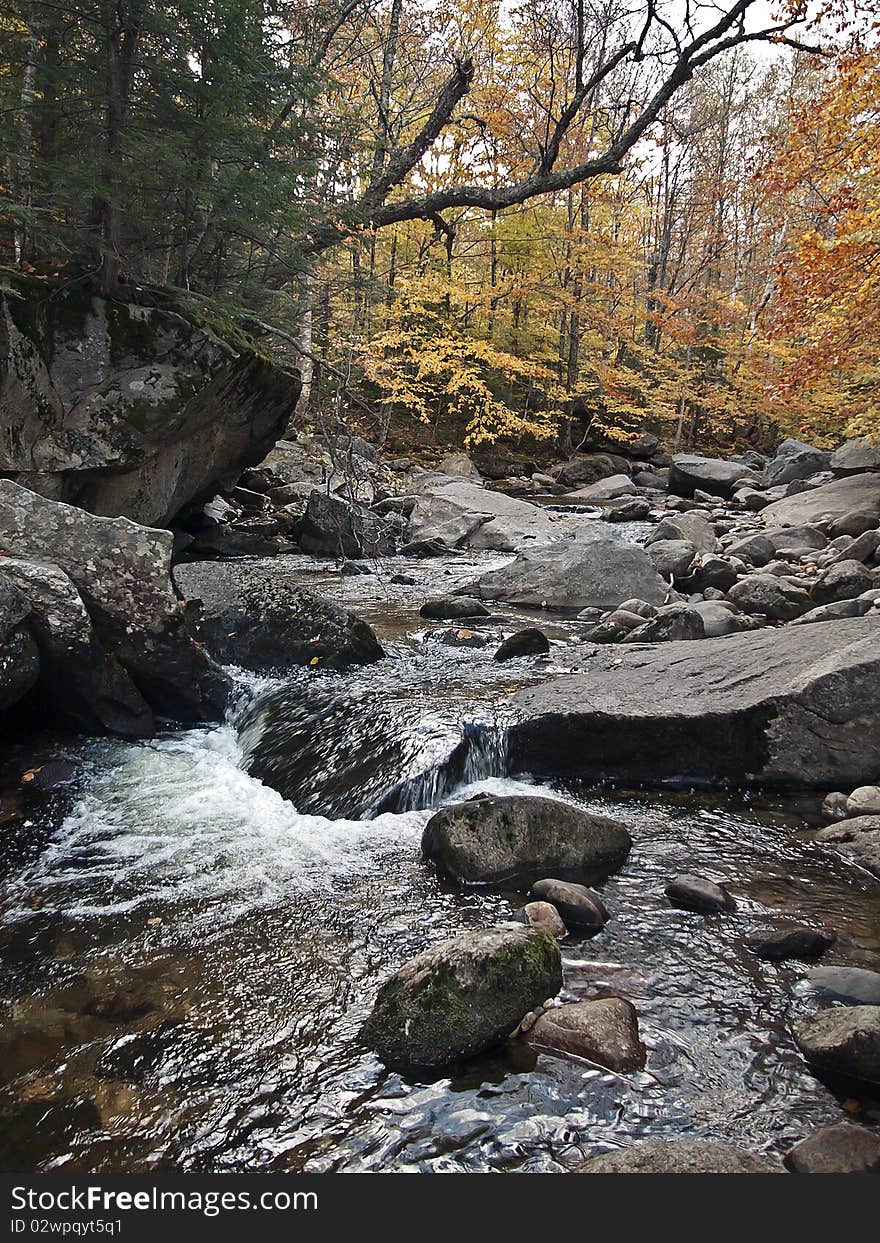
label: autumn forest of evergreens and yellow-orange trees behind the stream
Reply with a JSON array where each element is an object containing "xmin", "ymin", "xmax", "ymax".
[{"xmin": 0, "ymin": 0, "xmax": 880, "ymax": 449}]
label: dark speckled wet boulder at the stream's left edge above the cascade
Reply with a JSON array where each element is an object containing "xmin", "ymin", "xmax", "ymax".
[{"xmin": 174, "ymin": 561, "xmax": 383, "ymax": 670}]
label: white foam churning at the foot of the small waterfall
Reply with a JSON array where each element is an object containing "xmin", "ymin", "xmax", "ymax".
[{"xmin": 7, "ymin": 725, "xmax": 430, "ymax": 917}]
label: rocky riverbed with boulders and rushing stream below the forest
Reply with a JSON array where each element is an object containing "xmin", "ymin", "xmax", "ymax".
[{"xmin": 0, "ymin": 430, "xmax": 880, "ymax": 1172}]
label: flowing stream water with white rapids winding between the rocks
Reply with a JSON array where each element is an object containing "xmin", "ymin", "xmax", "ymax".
[{"xmin": 0, "ymin": 531, "xmax": 880, "ymax": 1171}]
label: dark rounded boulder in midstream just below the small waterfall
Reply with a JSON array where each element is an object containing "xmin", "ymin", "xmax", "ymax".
[{"xmin": 421, "ymin": 796, "xmax": 633, "ymax": 885}]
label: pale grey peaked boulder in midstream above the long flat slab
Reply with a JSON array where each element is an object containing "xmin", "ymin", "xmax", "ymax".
[{"xmin": 461, "ymin": 523, "xmax": 669, "ymax": 612}]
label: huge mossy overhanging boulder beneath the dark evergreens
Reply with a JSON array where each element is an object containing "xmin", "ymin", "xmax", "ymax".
[{"xmin": 0, "ymin": 280, "xmax": 300, "ymax": 526}]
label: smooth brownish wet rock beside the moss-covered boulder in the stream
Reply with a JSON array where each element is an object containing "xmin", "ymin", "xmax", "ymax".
[{"xmin": 528, "ymin": 997, "xmax": 648, "ymax": 1074}]
